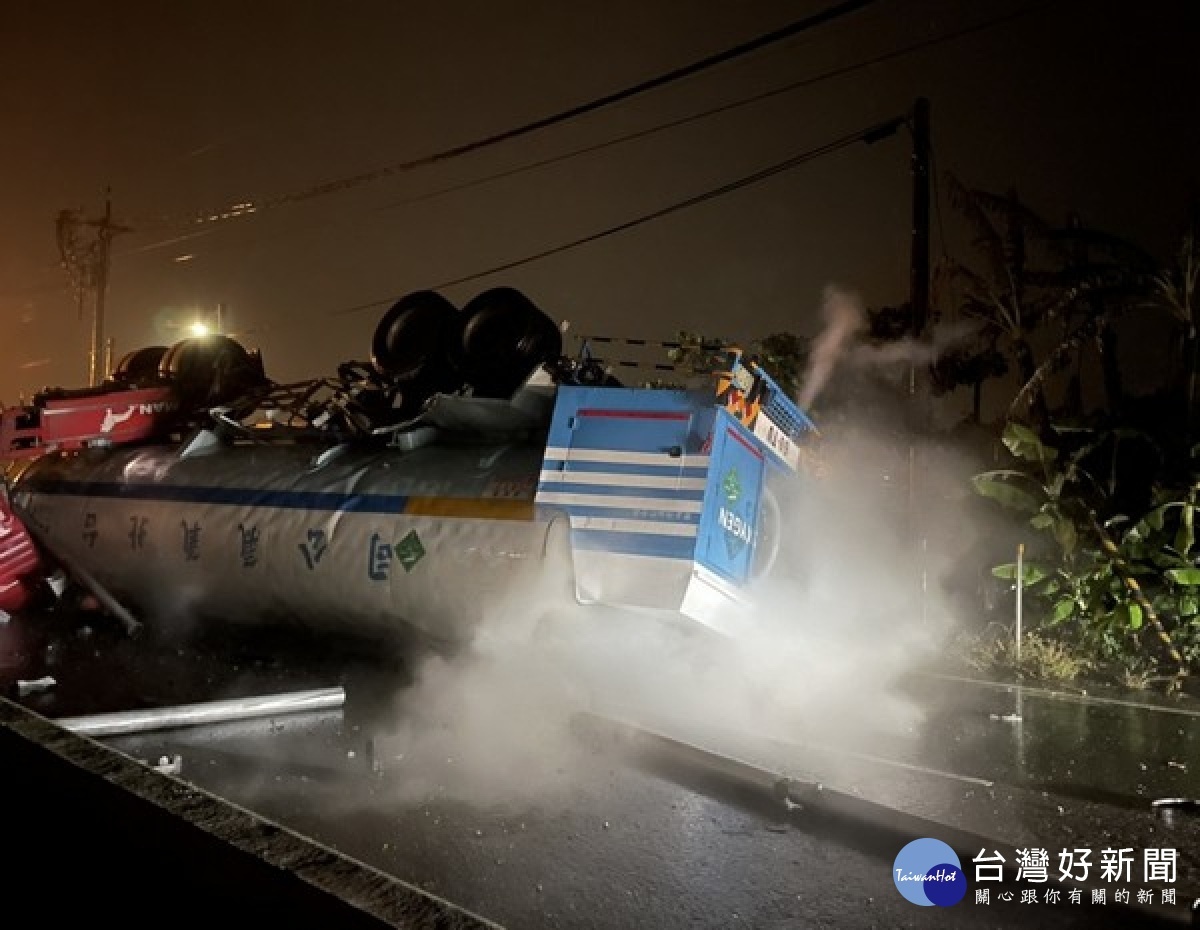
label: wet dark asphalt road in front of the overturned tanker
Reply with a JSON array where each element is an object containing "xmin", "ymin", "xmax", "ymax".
[{"xmin": 0, "ymin": 607, "xmax": 1200, "ymax": 928}]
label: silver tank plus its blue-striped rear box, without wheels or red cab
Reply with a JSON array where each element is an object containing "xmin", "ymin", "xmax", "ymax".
[{"xmin": 0, "ymin": 345, "xmax": 812, "ymax": 643}]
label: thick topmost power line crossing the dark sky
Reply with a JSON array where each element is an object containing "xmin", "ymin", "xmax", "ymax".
[{"xmin": 147, "ymin": 0, "xmax": 877, "ymax": 236}]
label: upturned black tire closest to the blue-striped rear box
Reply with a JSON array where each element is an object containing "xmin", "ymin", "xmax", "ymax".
[{"xmin": 454, "ymin": 287, "xmax": 563, "ymax": 397}]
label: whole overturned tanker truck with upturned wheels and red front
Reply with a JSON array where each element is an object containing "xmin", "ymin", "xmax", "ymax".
[{"xmin": 0, "ymin": 288, "xmax": 814, "ymax": 642}]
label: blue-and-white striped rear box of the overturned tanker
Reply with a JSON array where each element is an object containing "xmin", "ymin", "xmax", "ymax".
[{"xmin": 536, "ymin": 353, "xmax": 814, "ymax": 632}]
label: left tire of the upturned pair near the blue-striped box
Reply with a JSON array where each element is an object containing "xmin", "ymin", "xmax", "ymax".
[{"xmin": 371, "ymin": 290, "xmax": 458, "ymax": 384}]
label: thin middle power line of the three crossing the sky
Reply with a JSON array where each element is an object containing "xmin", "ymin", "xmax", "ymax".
[{"xmin": 118, "ymin": 0, "xmax": 1061, "ymax": 265}]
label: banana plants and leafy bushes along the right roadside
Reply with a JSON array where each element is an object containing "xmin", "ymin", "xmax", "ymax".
[{"xmin": 946, "ymin": 187, "xmax": 1200, "ymax": 690}]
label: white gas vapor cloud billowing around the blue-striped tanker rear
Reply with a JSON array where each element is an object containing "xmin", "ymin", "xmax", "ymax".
[{"xmin": 333, "ymin": 282, "xmax": 977, "ymax": 805}]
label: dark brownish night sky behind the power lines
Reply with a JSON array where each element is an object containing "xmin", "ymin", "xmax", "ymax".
[{"xmin": 0, "ymin": 0, "xmax": 1200, "ymax": 403}]
